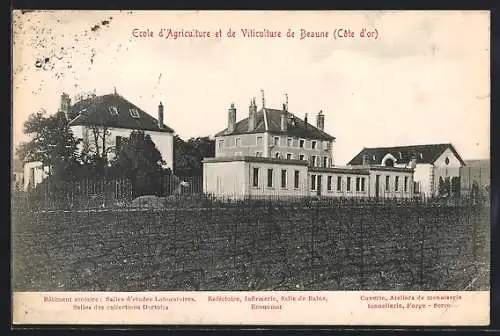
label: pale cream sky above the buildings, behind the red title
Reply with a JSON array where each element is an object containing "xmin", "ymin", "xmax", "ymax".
[{"xmin": 12, "ymin": 11, "xmax": 490, "ymax": 165}]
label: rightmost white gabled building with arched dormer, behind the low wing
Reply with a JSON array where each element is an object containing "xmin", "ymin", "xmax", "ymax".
[{"xmin": 348, "ymin": 143, "xmax": 465, "ymax": 197}]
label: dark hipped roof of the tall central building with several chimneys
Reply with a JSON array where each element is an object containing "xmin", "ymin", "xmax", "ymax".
[{"xmin": 215, "ymin": 108, "xmax": 335, "ymax": 140}]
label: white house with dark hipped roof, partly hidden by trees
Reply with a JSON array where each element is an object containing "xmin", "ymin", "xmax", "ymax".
[{"xmin": 24, "ymin": 92, "xmax": 174, "ymax": 189}]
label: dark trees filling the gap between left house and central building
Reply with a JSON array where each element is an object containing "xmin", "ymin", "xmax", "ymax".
[{"xmin": 174, "ymin": 135, "xmax": 215, "ymax": 177}]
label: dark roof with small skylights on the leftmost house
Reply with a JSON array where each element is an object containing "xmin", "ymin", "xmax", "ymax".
[{"xmin": 69, "ymin": 94, "xmax": 174, "ymax": 133}]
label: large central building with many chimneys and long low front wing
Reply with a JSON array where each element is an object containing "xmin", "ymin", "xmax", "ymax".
[{"xmin": 203, "ymin": 92, "xmax": 413, "ymax": 198}]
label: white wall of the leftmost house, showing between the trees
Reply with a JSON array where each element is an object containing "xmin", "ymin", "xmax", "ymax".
[{"xmin": 71, "ymin": 126, "xmax": 174, "ymax": 169}]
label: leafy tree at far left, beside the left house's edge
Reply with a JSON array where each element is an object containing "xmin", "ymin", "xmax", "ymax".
[{"xmin": 17, "ymin": 110, "xmax": 79, "ymax": 179}]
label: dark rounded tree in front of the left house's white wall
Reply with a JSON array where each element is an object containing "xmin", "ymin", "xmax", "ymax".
[{"xmin": 111, "ymin": 131, "xmax": 168, "ymax": 197}]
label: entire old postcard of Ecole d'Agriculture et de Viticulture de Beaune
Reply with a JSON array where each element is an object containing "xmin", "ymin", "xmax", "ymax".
[{"xmin": 11, "ymin": 10, "xmax": 491, "ymax": 326}]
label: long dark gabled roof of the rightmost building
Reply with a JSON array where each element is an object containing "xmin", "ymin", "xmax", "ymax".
[{"xmin": 347, "ymin": 143, "xmax": 465, "ymax": 165}]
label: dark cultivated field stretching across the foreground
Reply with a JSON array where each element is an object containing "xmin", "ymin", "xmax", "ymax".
[{"xmin": 13, "ymin": 198, "xmax": 490, "ymax": 291}]
